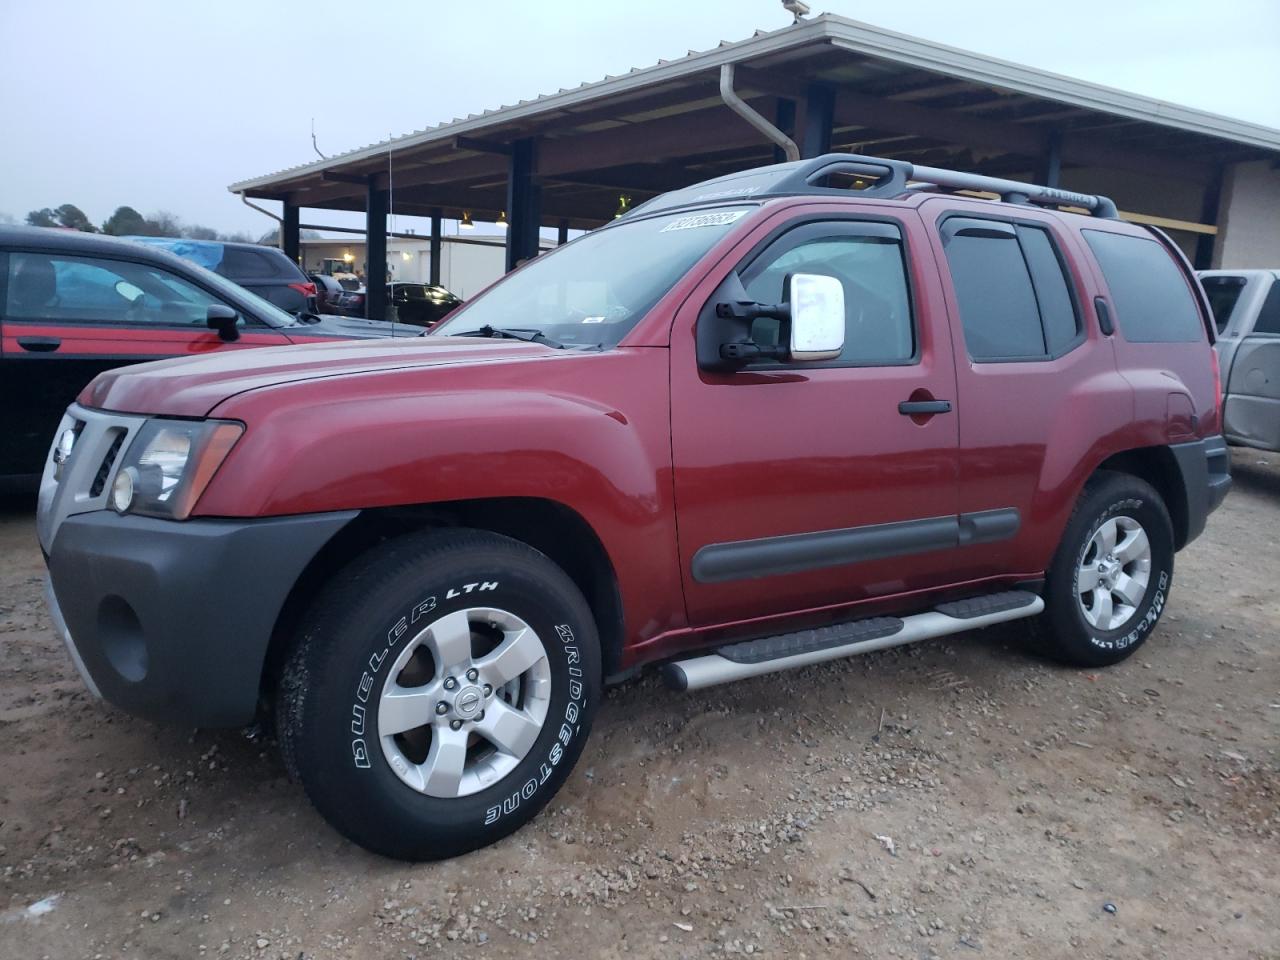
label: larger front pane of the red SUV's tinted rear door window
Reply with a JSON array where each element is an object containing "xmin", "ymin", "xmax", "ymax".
[{"xmin": 946, "ymin": 220, "xmax": 1061, "ymax": 360}]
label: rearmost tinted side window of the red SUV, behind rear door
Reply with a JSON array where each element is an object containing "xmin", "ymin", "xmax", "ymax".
[{"xmin": 1083, "ymin": 230, "xmax": 1204, "ymax": 343}]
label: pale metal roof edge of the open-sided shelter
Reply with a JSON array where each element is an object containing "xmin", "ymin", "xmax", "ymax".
[{"xmin": 229, "ymin": 14, "xmax": 1280, "ymax": 192}]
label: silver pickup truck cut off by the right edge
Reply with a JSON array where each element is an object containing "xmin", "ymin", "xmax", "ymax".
[{"xmin": 1198, "ymin": 270, "xmax": 1280, "ymax": 451}]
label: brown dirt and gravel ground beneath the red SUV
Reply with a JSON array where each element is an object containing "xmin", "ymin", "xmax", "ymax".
[{"xmin": 0, "ymin": 451, "xmax": 1280, "ymax": 960}]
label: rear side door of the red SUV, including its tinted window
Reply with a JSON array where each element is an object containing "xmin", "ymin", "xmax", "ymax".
[{"xmin": 920, "ymin": 198, "xmax": 1133, "ymax": 580}]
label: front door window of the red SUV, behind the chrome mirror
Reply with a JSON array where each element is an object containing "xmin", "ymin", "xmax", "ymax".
[{"xmin": 742, "ymin": 224, "xmax": 915, "ymax": 365}]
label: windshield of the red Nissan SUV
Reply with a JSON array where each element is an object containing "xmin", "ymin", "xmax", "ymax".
[{"xmin": 430, "ymin": 206, "xmax": 750, "ymax": 347}]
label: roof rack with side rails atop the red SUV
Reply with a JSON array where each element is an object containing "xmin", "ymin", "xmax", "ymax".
[{"xmin": 631, "ymin": 154, "xmax": 1119, "ymax": 219}]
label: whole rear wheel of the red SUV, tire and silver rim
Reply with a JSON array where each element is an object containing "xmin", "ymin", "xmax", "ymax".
[{"xmin": 1036, "ymin": 471, "xmax": 1174, "ymax": 667}]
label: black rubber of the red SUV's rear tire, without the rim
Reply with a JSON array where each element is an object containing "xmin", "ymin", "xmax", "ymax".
[{"xmin": 1048, "ymin": 476, "xmax": 1174, "ymax": 666}]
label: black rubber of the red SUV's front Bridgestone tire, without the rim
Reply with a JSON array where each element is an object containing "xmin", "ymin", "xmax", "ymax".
[{"xmin": 296, "ymin": 535, "xmax": 600, "ymax": 860}]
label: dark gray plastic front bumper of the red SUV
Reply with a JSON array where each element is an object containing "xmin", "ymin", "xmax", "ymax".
[{"xmin": 49, "ymin": 511, "xmax": 356, "ymax": 727}]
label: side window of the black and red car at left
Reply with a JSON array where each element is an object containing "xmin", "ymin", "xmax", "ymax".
[{"xmin": 4, "ymin": 252, "xmax": 234, "ymax": 326}]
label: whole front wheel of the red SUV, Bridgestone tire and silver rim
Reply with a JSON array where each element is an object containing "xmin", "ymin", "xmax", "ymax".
[{"xmin": 276, "ymin": 530, "xmax": 600, "ymax": 860}]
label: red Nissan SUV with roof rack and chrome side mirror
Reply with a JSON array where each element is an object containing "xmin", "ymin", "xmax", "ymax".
[{"xmin": 37, "ymin": 155, "xmax": 1230, "ymax": 859}]
